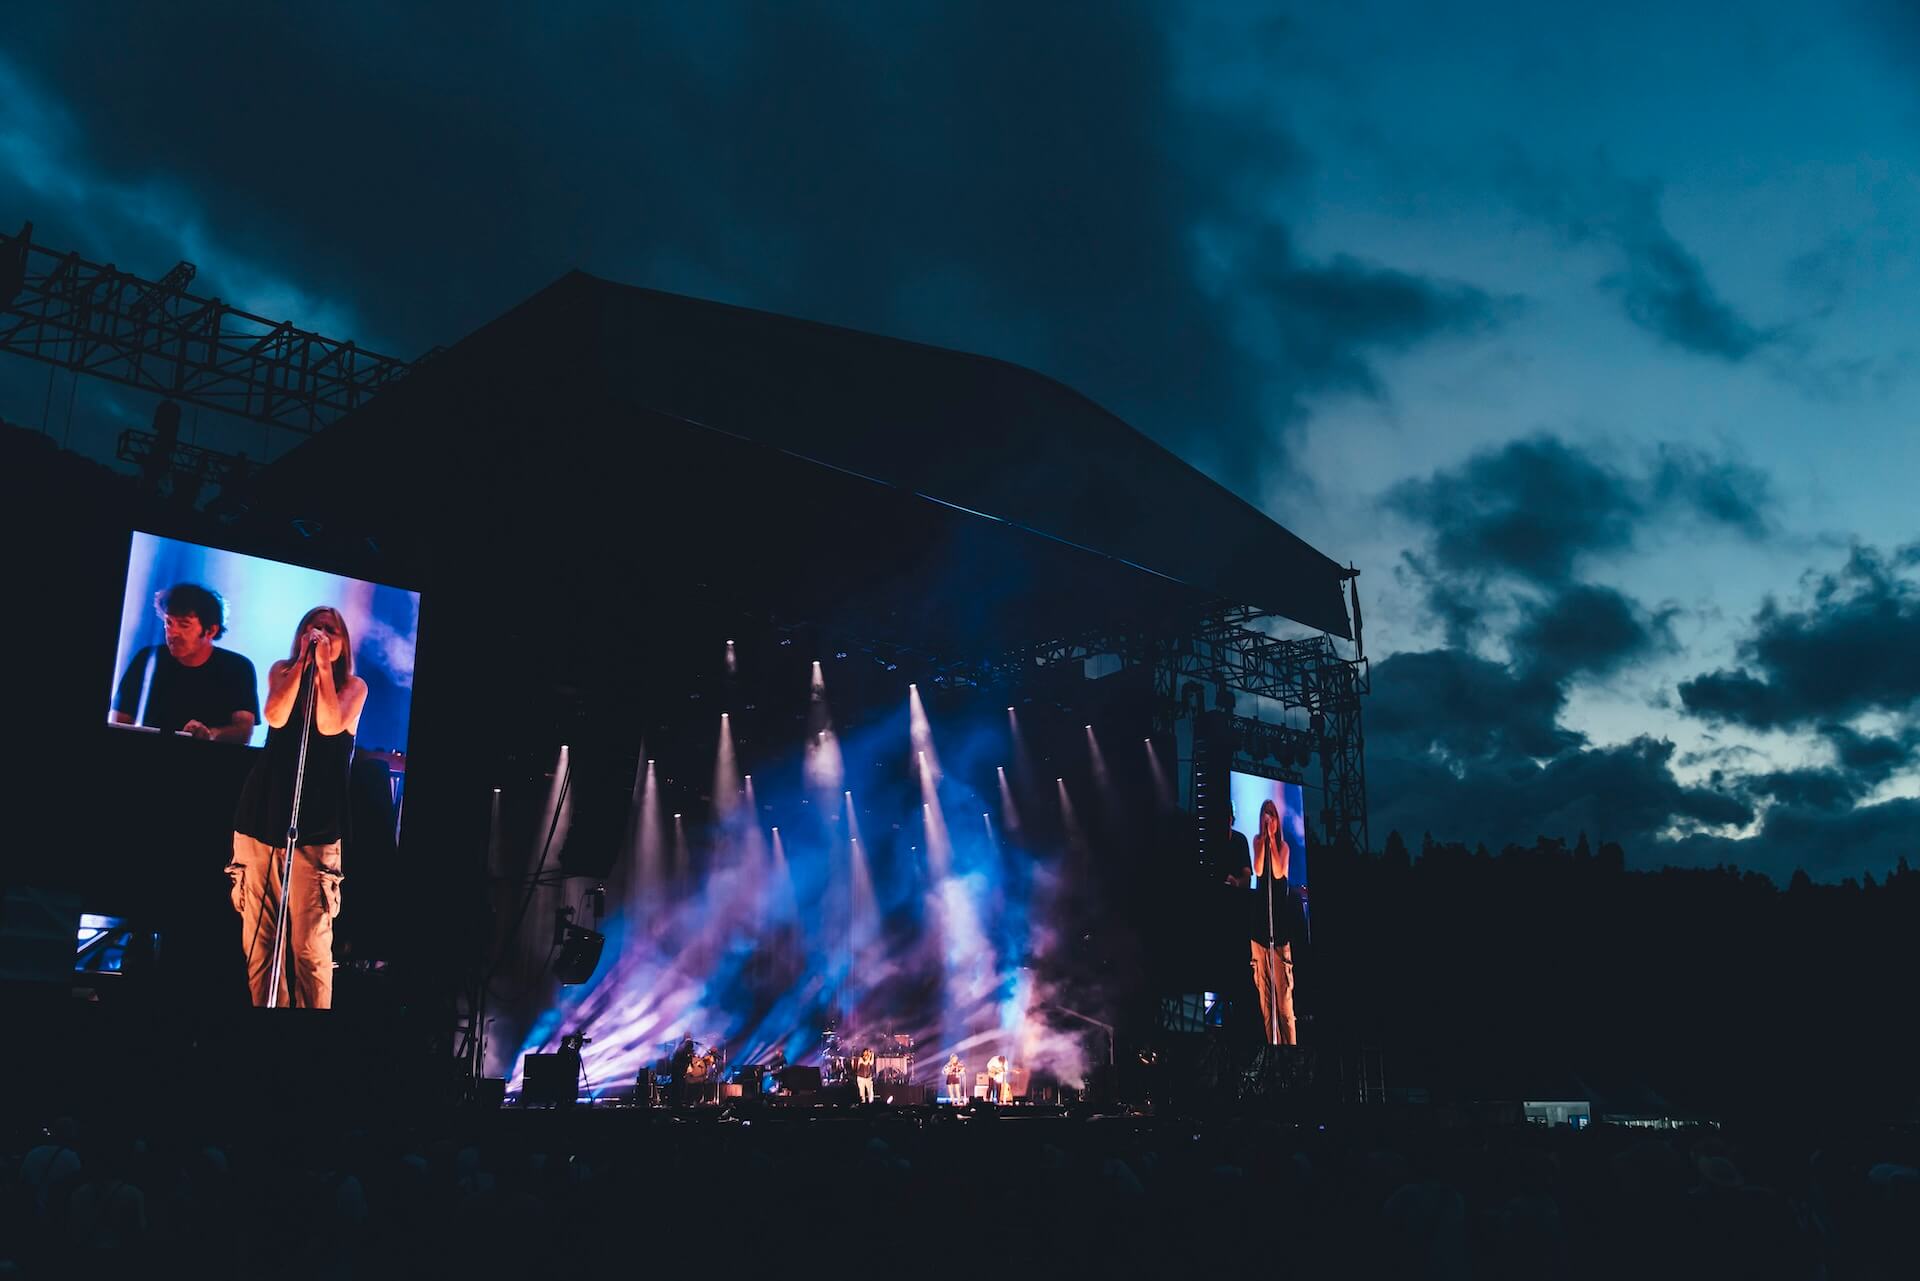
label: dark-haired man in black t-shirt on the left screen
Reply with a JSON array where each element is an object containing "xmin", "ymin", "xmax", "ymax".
[{"xmin": 113, "ymin": 582, "xmax": 259, "ymax": 743}]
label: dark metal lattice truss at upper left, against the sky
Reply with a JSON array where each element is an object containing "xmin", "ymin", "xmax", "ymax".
[{"xmin": 0, "ymin": 223, "xmax": 411, "ymax": 436}]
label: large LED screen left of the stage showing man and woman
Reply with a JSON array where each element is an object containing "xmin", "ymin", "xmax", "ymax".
[{"xmin": 108, "ymin": 532, "xmax": 420, "ymax": 1010}]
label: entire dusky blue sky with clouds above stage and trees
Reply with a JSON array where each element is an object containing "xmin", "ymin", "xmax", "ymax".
[{"xmin": 0, "ymin": 0, "xmax": 1920, "ymax": 880}]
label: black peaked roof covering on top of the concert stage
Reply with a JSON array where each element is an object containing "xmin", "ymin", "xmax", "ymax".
[{"xmin": 257, "ymin": 273, "xmax": 1350, "ymax": 636}]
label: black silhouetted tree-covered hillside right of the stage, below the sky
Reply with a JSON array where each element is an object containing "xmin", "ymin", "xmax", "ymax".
[{"xmin": 1302, "ymin": 832, "xmax": 1920, "ymax": 1116}]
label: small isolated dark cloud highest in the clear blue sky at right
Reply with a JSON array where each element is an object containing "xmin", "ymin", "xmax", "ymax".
[{"xmin": 1501, "ymin": 157, "xmax": 1774, "ymax": 361}]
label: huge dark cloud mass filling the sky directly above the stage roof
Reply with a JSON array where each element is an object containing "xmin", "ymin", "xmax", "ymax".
[{"xmin": 0, "ymin": 2, "xmax": 1492, "ymax": 492}]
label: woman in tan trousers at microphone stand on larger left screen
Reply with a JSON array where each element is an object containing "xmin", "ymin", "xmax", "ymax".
[{"xmin": 227, "ymin": 605, "xmax": 367, "ymax": 1010}]
